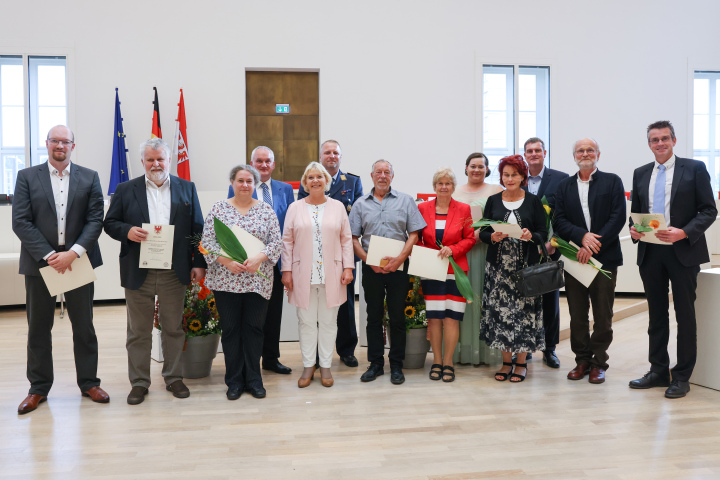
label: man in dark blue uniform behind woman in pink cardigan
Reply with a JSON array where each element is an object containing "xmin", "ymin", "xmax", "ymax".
[{"xmin": 298, "ymin": 140, "xmax": 362, "ymax": 367}]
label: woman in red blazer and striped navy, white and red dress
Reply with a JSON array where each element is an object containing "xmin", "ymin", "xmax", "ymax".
[{"xmin": 418, "ymin": 168, "xmax": 475, "ymax": 382}]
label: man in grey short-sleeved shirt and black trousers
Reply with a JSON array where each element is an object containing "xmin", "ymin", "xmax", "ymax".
[{"xmin": 350, "ymin": 160, "xmax": 426, "ymax": 385}]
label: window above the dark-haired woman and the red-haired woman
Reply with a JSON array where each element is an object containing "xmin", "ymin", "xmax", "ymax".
[{"xmin": 482, "ymin": 65, "xmax": 550, "ymax": 182}]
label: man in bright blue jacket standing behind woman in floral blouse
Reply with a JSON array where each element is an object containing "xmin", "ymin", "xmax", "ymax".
[{"xmin": 228, "ymin": 146, "xmax": 295, "ymax": 375}]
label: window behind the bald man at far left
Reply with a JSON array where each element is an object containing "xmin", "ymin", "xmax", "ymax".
[{"xmin": 0, "ymin": 55, "xmax": 67, "ymax": 193}]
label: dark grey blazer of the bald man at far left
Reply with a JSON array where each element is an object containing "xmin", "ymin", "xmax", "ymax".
[{"xmin": 12, "ymin": 162, "xmax": 104, "ymax": 276}]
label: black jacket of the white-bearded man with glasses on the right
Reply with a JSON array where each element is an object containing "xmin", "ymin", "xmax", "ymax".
[{"xmin": 553, "ymin": 170, "xmax": 627, "ymax": 267}]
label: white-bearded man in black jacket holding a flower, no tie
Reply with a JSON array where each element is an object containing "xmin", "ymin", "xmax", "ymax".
[{"xmin": 553, "ymin": 138, "xmax": 626, "ymax": 383}]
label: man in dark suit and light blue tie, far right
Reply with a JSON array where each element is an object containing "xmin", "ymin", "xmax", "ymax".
[{"xmin": 630, "ymin": 120, "xmax": 717, "ymax": 398}]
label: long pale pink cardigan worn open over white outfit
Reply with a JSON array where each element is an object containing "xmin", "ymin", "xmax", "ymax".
[{"xmin": 281, "ymin": 198, "xmax": 355, "ymax": 309}]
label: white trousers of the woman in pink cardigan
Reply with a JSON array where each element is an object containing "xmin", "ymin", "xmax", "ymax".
[{"xmin": 297, "ymin": 285, "xmax": 340, "ymax": 368}]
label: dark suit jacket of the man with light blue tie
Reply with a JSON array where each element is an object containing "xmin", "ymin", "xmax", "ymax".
[{"xmin": 629, "ymin": 156, "xmax": 717, "ymax": 267}]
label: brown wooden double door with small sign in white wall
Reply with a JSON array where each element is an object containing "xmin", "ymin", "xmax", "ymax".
[{"xmin": 245, "ymin": 72, "xmax": 320, "ymax": 181}]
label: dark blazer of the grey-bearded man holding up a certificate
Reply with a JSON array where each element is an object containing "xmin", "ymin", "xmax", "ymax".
[{"xmin": 104, "ymin": 175, "xmax": 207, "ymax": 290}]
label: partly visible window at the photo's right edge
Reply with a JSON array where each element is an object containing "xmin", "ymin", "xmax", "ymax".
[{"xmin": 693, "ymin": 71, "xmax": 720, "ymax": 192}]
